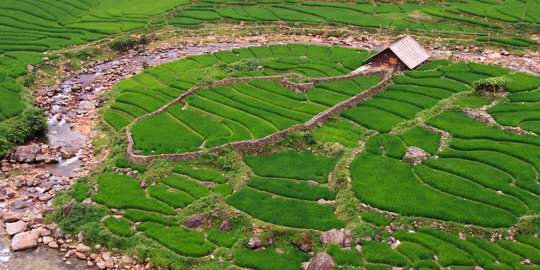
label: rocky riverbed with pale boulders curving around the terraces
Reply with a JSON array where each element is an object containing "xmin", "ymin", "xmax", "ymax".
[{"xmin": 0, "ymin": 35, "xmax": 540, "ymax": 269}]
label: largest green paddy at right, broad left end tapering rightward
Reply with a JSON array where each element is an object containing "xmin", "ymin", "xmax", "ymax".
[{"xmin": 351, "ymin": 154, "xmax": 516, "ymax": 227}]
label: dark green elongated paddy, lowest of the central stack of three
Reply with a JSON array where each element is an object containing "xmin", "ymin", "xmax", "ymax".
[{"xmin": 227, "ymin": 188, "xmax": 345, "ymax": 231}]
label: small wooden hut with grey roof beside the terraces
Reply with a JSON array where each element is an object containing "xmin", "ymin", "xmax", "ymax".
[{"xmin": 369, "ymin": 36, "xmax": 429, "ymax": 71}]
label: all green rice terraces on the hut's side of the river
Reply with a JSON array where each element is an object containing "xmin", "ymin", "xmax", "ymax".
[{"xmin": 61, "ymin": 41, "xmax": 540, "ymax": 269}]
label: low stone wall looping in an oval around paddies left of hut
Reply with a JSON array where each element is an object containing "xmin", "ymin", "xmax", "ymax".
[{"xmin": 126, "ymin": 68, "xmax": 392, "ymax": 164}]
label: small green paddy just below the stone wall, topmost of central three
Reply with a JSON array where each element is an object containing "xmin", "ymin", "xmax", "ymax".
[{"xmin": 244, "ymin": 151, "xmax": 336, "ymax": 183}]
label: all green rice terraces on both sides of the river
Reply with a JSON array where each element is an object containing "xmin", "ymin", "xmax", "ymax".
[{"xmin": 0, "ymin": 0, "xmax": 540, "ymax": 270}]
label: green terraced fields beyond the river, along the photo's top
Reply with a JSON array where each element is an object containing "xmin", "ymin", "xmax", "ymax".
[{"xmin": 0, "ymin": 0, "xmax": 540, "ymax": 134}]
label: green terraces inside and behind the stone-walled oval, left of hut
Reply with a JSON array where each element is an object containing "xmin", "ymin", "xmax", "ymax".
[{"xmin": 105, "ymin": 44, "xmax": 380, "ymax": 155}]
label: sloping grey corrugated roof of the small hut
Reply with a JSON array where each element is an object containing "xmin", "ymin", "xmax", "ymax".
[{"xmin": 370, "ymin": 36, "xmax": 429, "ymax": 69}]
